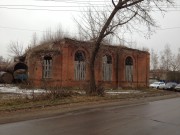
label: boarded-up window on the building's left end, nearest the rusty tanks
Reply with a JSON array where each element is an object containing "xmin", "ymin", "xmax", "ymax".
[{"xmin": 43, "ymin": 56, "xmax": 52, "ymax": 78}]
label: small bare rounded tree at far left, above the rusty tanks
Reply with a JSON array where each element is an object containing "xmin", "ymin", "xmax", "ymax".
[{"xmin": 8, "ymin": 41, "xmax": 24, "ymax": 57}]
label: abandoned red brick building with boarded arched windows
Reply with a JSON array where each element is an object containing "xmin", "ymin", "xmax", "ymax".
[{"xmin": 26, "ymin": 38, "xmax": 149, "ymax": 88}]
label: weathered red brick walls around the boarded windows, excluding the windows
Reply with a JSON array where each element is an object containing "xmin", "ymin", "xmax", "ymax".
[{"xmin": 27, "ymin": 39, "xmax": 149, "ymax": 88}]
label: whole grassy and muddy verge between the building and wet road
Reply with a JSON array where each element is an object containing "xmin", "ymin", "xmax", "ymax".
[{"xmin": 0, "ymin": 86, "xmax": 180, "ymax": 124}]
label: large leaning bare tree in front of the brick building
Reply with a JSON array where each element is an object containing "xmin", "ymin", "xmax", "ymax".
[{"xmin": 76, "ymin": 0, "xmax": 173, "ymax": 95}]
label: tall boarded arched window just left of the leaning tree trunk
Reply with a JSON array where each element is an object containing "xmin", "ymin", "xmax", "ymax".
[{"xmin": 74, "ymin": 51, "xmax": 86, "ymax": 80}]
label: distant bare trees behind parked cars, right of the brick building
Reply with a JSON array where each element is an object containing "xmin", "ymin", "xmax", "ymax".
[{"xmin": 150, "ymin": 44, "xmax": 180, "ymax": 82}]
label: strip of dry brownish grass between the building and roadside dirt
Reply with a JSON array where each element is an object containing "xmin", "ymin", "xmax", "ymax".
[{"xmin": 0, "ymin": 89, "xmax": 174, "ymax": 111}]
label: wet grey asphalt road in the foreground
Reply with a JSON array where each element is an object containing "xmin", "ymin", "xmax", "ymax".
[{"xmin": 0, "ymin": 98, "xmax": 180, "ymax": 135}]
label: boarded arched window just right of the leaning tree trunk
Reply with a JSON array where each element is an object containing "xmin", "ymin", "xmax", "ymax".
[{"xmin": 102, "ymin": 55, "xmax": 112, "ymax": 81}]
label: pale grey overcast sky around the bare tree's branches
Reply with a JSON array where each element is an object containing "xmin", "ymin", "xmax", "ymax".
[{"xmin": 0, "ymin": 0, "xmax": 180, "ymax": 57}]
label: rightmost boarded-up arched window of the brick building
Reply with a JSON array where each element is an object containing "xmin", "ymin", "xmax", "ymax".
[{"xmin": 125, "ymin": 57, "xmax": 133, "ymax": 82}]
